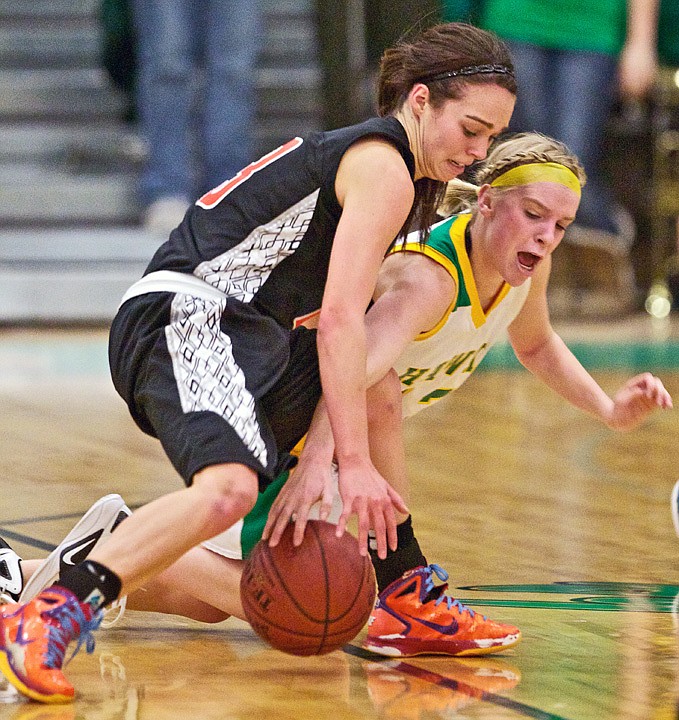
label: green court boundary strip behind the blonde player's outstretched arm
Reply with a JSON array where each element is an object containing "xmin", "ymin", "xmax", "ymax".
[{"xmin": 479, "ymin": 340, "xmax": 679, "ymax": 371}]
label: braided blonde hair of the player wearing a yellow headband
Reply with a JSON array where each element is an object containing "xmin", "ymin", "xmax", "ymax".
[{"xmin": 439, "ymin": 132, "xmax": 587, "ymax": 217}]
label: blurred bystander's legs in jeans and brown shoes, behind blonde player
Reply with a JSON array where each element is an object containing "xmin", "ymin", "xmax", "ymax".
[{"xmin": 510, "ymin": 43, "xmax": 636, "ymax": 317}]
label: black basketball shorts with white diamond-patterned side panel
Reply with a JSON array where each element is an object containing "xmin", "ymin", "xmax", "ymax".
[{"xmin": 109, "ymin": 292, "xmax": 321, "ymax": 489}]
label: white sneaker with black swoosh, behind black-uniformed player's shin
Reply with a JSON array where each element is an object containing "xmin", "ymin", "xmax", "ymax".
[{"xmin": 19, "ymin": 494, "xmax": 132, "ymax": 603}]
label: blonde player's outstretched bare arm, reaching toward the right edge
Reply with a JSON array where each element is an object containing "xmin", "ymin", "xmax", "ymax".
[{"xmin": 509, "ymin": 264, "xmax": 672, "ymax": 430}]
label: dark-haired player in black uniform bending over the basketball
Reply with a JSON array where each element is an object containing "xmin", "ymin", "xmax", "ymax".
[{"xmin": 0, "ymin": 23, "xmax": 516, "ymax": 702}]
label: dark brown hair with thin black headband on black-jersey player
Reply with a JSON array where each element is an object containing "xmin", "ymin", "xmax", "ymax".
[{"xmin": 378, "ymin": 23, "xmax": 516, "ymax": 245}]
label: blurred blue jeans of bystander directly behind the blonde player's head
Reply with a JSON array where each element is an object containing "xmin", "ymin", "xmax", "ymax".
[{"xmin": 509, "ymin": 43, "xmax": 617, "ymax": 233}]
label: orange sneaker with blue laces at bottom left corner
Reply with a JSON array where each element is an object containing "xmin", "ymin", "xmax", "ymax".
[{"xmin": 0, "ymin": 586, "xmax": 102, "ymax": 703}]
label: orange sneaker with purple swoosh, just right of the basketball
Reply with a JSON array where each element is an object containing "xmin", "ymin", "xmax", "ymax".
[{"xmin": 364, "ymin": 565, "xmax": 521, "ymax": 657}]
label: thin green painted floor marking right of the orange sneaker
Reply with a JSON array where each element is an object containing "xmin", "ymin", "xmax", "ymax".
[{"xmin": 458, "ymin": 582, "xmax": 679, "ymax": 613}]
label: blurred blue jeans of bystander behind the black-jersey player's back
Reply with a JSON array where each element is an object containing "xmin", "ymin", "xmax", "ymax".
[{"xmin": 133, "ymin": 0, "xmax": 259, "ymax": 203}]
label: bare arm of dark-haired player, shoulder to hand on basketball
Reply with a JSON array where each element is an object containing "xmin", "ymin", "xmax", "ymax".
[{"xmin": 317, "ymin": 139, "xmax": 414, "ymax": 553}]
